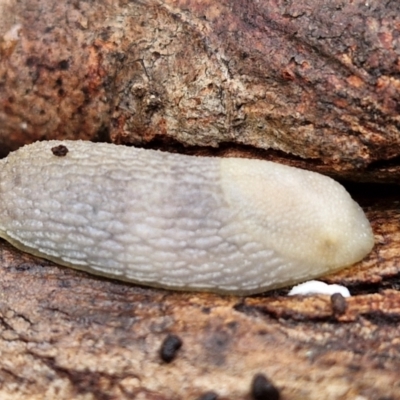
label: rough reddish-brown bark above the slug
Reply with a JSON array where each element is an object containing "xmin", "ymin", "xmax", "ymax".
[{"xmin": 0, "ymin": 0, "xmax": 400, "ymax": 182}]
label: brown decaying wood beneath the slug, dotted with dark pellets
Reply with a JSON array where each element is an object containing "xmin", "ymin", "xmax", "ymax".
[{"xmin": 0, "ymin": 189, "xmax": 400, "ymax": 400}]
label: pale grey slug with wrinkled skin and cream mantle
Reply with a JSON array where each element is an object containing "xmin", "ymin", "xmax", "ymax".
[{"xmin": 0, "ymin": 141, "xmax": 374, "ymax": 295}]
